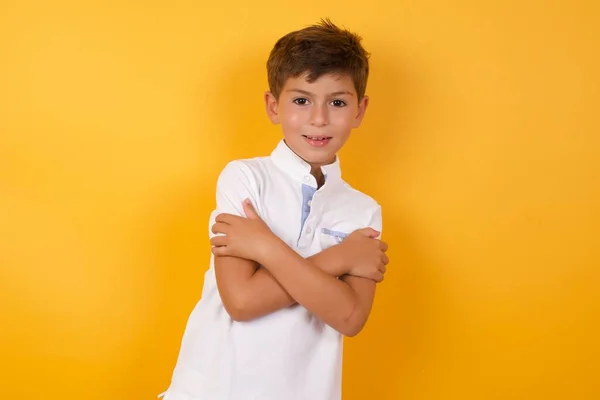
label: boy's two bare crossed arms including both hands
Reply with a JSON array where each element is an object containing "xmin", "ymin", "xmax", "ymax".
[{"xmin": 211, "ymin": 203, "xmax": 389, "ymax": 336}]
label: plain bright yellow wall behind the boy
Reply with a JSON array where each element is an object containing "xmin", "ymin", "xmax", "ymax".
[{"xmin": 0, "ymin": 0, "xmax": 600, "ymax": 400}]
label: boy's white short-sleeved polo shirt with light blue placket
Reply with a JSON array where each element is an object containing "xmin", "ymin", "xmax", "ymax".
[{"xmin": 164, "ymin": 140, "xmax": 381, "ymax": 400}]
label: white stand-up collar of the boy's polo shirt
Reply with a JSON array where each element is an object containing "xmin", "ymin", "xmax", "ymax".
[{"xmin": 271, "ymin": 139, "xmax": 342, "ymax": 186}]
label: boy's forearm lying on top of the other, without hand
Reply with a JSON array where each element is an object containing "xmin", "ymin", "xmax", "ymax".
[{"xmin": 259, "ymin": 242, "xmax": 360, "ymax": 335}]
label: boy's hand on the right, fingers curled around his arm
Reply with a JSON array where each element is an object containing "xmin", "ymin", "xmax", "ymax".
[{"xmin": 340, "ymin": 228, "xmax": 389, "ymax": 282}]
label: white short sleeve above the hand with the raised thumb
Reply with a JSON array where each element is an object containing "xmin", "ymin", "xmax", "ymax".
[{"xmin": 208, "ymin": 161, "xmax": 259, "ymax": 238}]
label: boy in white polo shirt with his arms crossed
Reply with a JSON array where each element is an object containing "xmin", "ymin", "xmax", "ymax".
[{"xmin": 165, "ymin": 21, "xmax": 388, "ymax": 400}]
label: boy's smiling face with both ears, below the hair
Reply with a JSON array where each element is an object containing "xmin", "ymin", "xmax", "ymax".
[{"xmin": 265, "ymin": 75, "xmax": 368, "ymax": 168}]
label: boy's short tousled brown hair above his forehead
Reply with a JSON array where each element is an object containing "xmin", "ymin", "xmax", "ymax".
[{"xmin": 267, "ymin": 19, "xmax": 369, "ymax": 100}]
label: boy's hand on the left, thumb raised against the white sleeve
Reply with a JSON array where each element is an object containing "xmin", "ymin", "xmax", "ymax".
[{"xmin": 210, "ymin": 200, "xmax": 278, "ymax": 263}]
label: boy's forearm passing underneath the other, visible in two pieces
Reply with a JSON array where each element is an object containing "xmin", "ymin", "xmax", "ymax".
[{"xmin": 231, "ymin": 246, "xmax": 347, "ymax": 320}]
